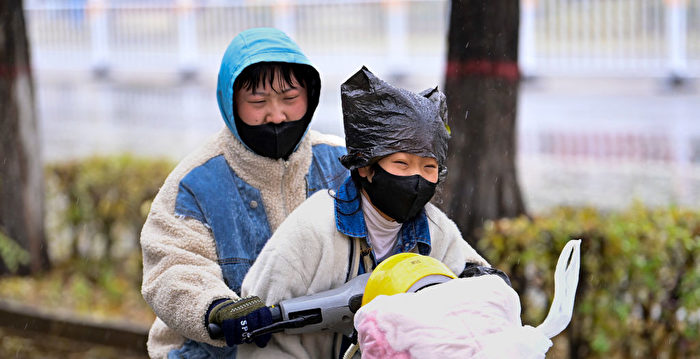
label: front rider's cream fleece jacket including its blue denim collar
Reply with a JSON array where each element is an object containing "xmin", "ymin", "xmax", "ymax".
[{"xmin": 239, "ymin": 177, "xmax": 488, "ymax": 358}]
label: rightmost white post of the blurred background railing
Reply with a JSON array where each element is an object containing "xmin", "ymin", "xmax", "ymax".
[{"xmin": 665, "ymin": 0, "xmax": 688, "ymax": 84}]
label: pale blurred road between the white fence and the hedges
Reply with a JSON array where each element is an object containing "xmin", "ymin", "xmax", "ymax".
[{"xmin": 37, "ymin": 74, "xmax": 700, "ymax": 211}]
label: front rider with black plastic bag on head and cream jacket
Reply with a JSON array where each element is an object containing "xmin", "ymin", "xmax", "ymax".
[{"xmin": 239, "ymin": 68, "xmax": 507, "ymax": 358}]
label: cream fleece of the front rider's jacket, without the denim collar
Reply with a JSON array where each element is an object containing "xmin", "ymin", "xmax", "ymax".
[{"xmin": 238, "ymin": 190, "xmax": 488, "ymax": 359}]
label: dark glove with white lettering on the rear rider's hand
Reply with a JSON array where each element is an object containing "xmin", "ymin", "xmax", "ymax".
[{"xmin": 208, "ymin": 296, "xmax": 272, "ymax": 348}]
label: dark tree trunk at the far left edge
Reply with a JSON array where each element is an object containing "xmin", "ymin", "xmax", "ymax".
[{"xmin": 0, "ymin": 0, "xmax": 48, "ymax": 274}]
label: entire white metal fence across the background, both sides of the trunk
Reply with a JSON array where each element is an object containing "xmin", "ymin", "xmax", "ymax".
[{"xmin": 26, "ymin": 0, "xmax": 700, "ymax": 77}]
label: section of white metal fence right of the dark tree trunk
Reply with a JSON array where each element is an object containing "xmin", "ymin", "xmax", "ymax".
[{"xmin": 521, "ymin": 0, "xmax": 700, "ymax": 76}]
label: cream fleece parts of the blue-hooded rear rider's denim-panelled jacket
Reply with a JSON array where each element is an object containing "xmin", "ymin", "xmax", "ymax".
[{"xmin": 141, "ymin": 127, "xmax": 344, "ymax": 358}]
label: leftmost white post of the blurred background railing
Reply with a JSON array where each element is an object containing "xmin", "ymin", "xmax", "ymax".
[{"xmin": 87, "ymin": 0, "xmax": 111, "ymax": 77}]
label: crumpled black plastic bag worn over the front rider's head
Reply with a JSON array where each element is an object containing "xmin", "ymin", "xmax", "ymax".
[{"xmin": 340, "ymin": 66, "xmax": 450, "ymax": 177}]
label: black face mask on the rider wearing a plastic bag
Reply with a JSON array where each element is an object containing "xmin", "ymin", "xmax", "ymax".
[{"xmin": 360, "ymin": 164, "xmax": 437, "ymax": 223}]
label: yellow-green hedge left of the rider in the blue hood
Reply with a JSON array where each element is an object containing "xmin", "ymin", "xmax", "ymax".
[{"xmin": 46, "ymin": 155, "xmax": 174, "ymax": 262}]
